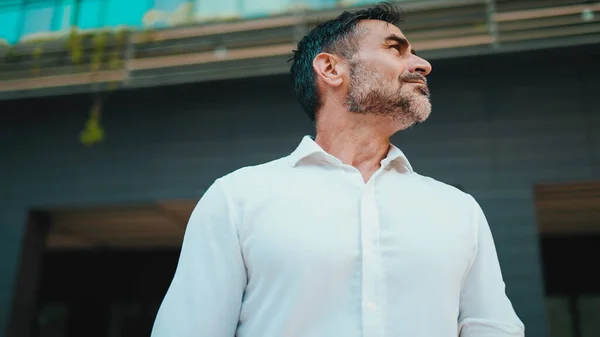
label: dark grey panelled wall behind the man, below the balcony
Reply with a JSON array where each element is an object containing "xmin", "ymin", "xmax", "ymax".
[{"xmin": 0, "ymin": 47, "xmax": 600, "ymax": 337}]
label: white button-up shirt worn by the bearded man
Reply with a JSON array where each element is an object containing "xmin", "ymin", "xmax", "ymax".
[{"xmin": 152, "ymin": 137, "xmax": 524, "ymax": 337}]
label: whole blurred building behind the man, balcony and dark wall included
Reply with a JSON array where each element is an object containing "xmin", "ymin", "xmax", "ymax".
[{"xmin": 0, "ymin": 0, "xmax": 600, "ymax": 337}]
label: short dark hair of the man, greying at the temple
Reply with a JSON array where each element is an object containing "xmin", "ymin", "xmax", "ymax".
[{"xmin": 290, "ymin": 2, "xmax": 403, "ymax": 121}]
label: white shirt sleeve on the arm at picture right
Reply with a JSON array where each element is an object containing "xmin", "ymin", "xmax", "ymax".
[{"xmin": 458, "ymin": 201, "xmax": 525, "ymax": 337}]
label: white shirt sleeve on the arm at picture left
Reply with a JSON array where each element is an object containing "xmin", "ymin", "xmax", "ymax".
[{"xmin": 151, "ymin": 180, "xmax": 246, "ymax": 337}]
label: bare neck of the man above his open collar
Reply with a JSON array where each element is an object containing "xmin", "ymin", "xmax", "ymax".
[{"xmin": 315, "ymin": 107, "xmax": 393, "ymax": 175}]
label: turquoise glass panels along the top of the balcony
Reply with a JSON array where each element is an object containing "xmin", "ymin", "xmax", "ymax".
[{"xmin": 0, "ymin": 0, "xmax": 394, "ymax": 44}]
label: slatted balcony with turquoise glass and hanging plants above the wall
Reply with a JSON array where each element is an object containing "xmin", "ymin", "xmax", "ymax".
[{"xmin": 0, "ymin": 0, "xmax": 600, "ymax": 99}]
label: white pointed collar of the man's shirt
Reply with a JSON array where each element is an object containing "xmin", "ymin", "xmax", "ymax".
[{"xmin": 289, "ymin": 136, "xmax": 413, "ymax": 173}]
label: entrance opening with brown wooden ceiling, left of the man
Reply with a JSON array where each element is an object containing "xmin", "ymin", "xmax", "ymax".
[{"xmin": 31, "ymin": 201, "xmax": 195, "ymax": 337}]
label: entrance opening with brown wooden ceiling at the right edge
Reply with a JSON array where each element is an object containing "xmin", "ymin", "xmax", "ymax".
[{"xmin": 535, "ymin": 182, "xmax": 600, "ymax": 337}]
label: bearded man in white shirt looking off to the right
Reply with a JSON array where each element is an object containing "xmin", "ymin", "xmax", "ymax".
[{"xmin": 153, "ymin": 4, "xmax": 524, "ymax": 337}]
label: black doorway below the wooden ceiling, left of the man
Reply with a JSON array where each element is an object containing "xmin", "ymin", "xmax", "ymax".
[{"xmin": 34, "ymin": 250, "xmax": 179, "ymax": 337}]
